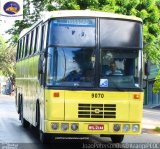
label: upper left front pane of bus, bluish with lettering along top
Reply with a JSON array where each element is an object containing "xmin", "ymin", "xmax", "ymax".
[{"xmin": 49, "ymin": 18, "xmax": 96, "ymax": 47}]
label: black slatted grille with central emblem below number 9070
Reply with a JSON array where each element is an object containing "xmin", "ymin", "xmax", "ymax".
[{"xmin": 78, "ymin": 104, "xmax": 116, "ymax": 118}]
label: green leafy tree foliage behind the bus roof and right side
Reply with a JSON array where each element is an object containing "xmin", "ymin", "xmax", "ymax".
[{"xmin": 5, "ymin": 0, "xmax": 160, "ymax": 91}]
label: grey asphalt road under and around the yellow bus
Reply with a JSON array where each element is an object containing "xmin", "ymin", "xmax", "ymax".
[{"xmin": 0, "ymin": 95, "xmax": 160, "ymax": 149}]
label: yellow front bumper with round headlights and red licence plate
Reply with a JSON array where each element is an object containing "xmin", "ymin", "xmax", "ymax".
[{"xmin": 44, "ymin": 120, "xmax": 141, "ymax": 135}]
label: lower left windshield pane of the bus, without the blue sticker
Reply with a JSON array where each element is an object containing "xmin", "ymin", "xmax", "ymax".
[{"xmin": 47, "ymin": 47, "xmax": 95, "ymax": 87}]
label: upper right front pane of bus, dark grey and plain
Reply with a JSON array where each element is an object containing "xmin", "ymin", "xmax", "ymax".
[{"xmin": 100, "ymin": 19, "xmax": 142, "ymax": 49}]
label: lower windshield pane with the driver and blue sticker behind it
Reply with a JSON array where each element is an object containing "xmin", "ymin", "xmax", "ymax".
[{"xmin": 100, "ymin": 49, "xmax": 141, "ymax": 88}]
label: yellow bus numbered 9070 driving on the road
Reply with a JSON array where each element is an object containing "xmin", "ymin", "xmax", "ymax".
[{"xmin": 15, "ymin": 10, "xmax": 144, "ymax": 143}]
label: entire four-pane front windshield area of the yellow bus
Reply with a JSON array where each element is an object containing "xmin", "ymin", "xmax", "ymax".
[{"xmin": 46, "ymin": 18, "xmax": 142, "ymax": 89}]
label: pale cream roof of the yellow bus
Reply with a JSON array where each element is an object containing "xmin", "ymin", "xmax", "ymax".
[{"xmin": 20, "ymin": 10, "xmax": 142, "ymax": 38}]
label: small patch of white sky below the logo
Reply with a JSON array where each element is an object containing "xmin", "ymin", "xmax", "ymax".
[{"xmin": 0, "ymin": 20, "xmax": 14, "ymax": 40}]
